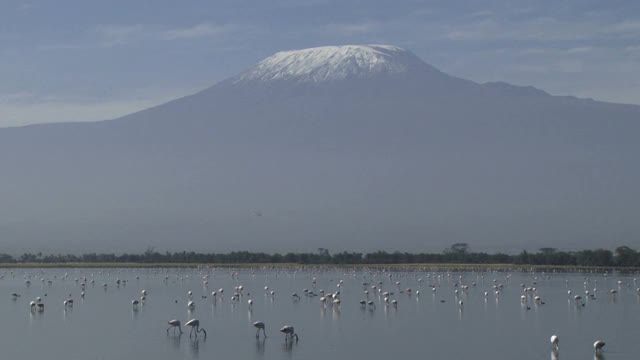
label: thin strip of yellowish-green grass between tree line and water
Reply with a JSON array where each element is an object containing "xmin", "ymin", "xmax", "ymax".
[{"xmin": 0, "ymin": 262, "xmax": 640, "ymax": 271}]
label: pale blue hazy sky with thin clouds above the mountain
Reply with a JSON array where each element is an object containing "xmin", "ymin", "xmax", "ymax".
[{"xmin": 0, "ymin": 0, "xmax": 640, "ymax": 126}]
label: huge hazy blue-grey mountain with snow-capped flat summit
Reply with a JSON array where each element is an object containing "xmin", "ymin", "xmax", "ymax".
[{"xmin": 0, "ymin": 45, "xmax": 640, "ymax": 252}]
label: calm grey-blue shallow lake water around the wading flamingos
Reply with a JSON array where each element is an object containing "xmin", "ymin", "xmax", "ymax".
[{"xmin": 0, "ymin": 269, "xmax": 640, "ymax": 360}]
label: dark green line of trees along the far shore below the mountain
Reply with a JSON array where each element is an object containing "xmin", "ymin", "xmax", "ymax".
[{"xmin": 0, "ymin": 243, "xmax": 640, "ymax": 267}]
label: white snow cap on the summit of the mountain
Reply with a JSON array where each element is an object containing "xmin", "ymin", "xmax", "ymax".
[{"xmin": 236, "ymin": 45, "xmax": 428, "ymax": 82}]
